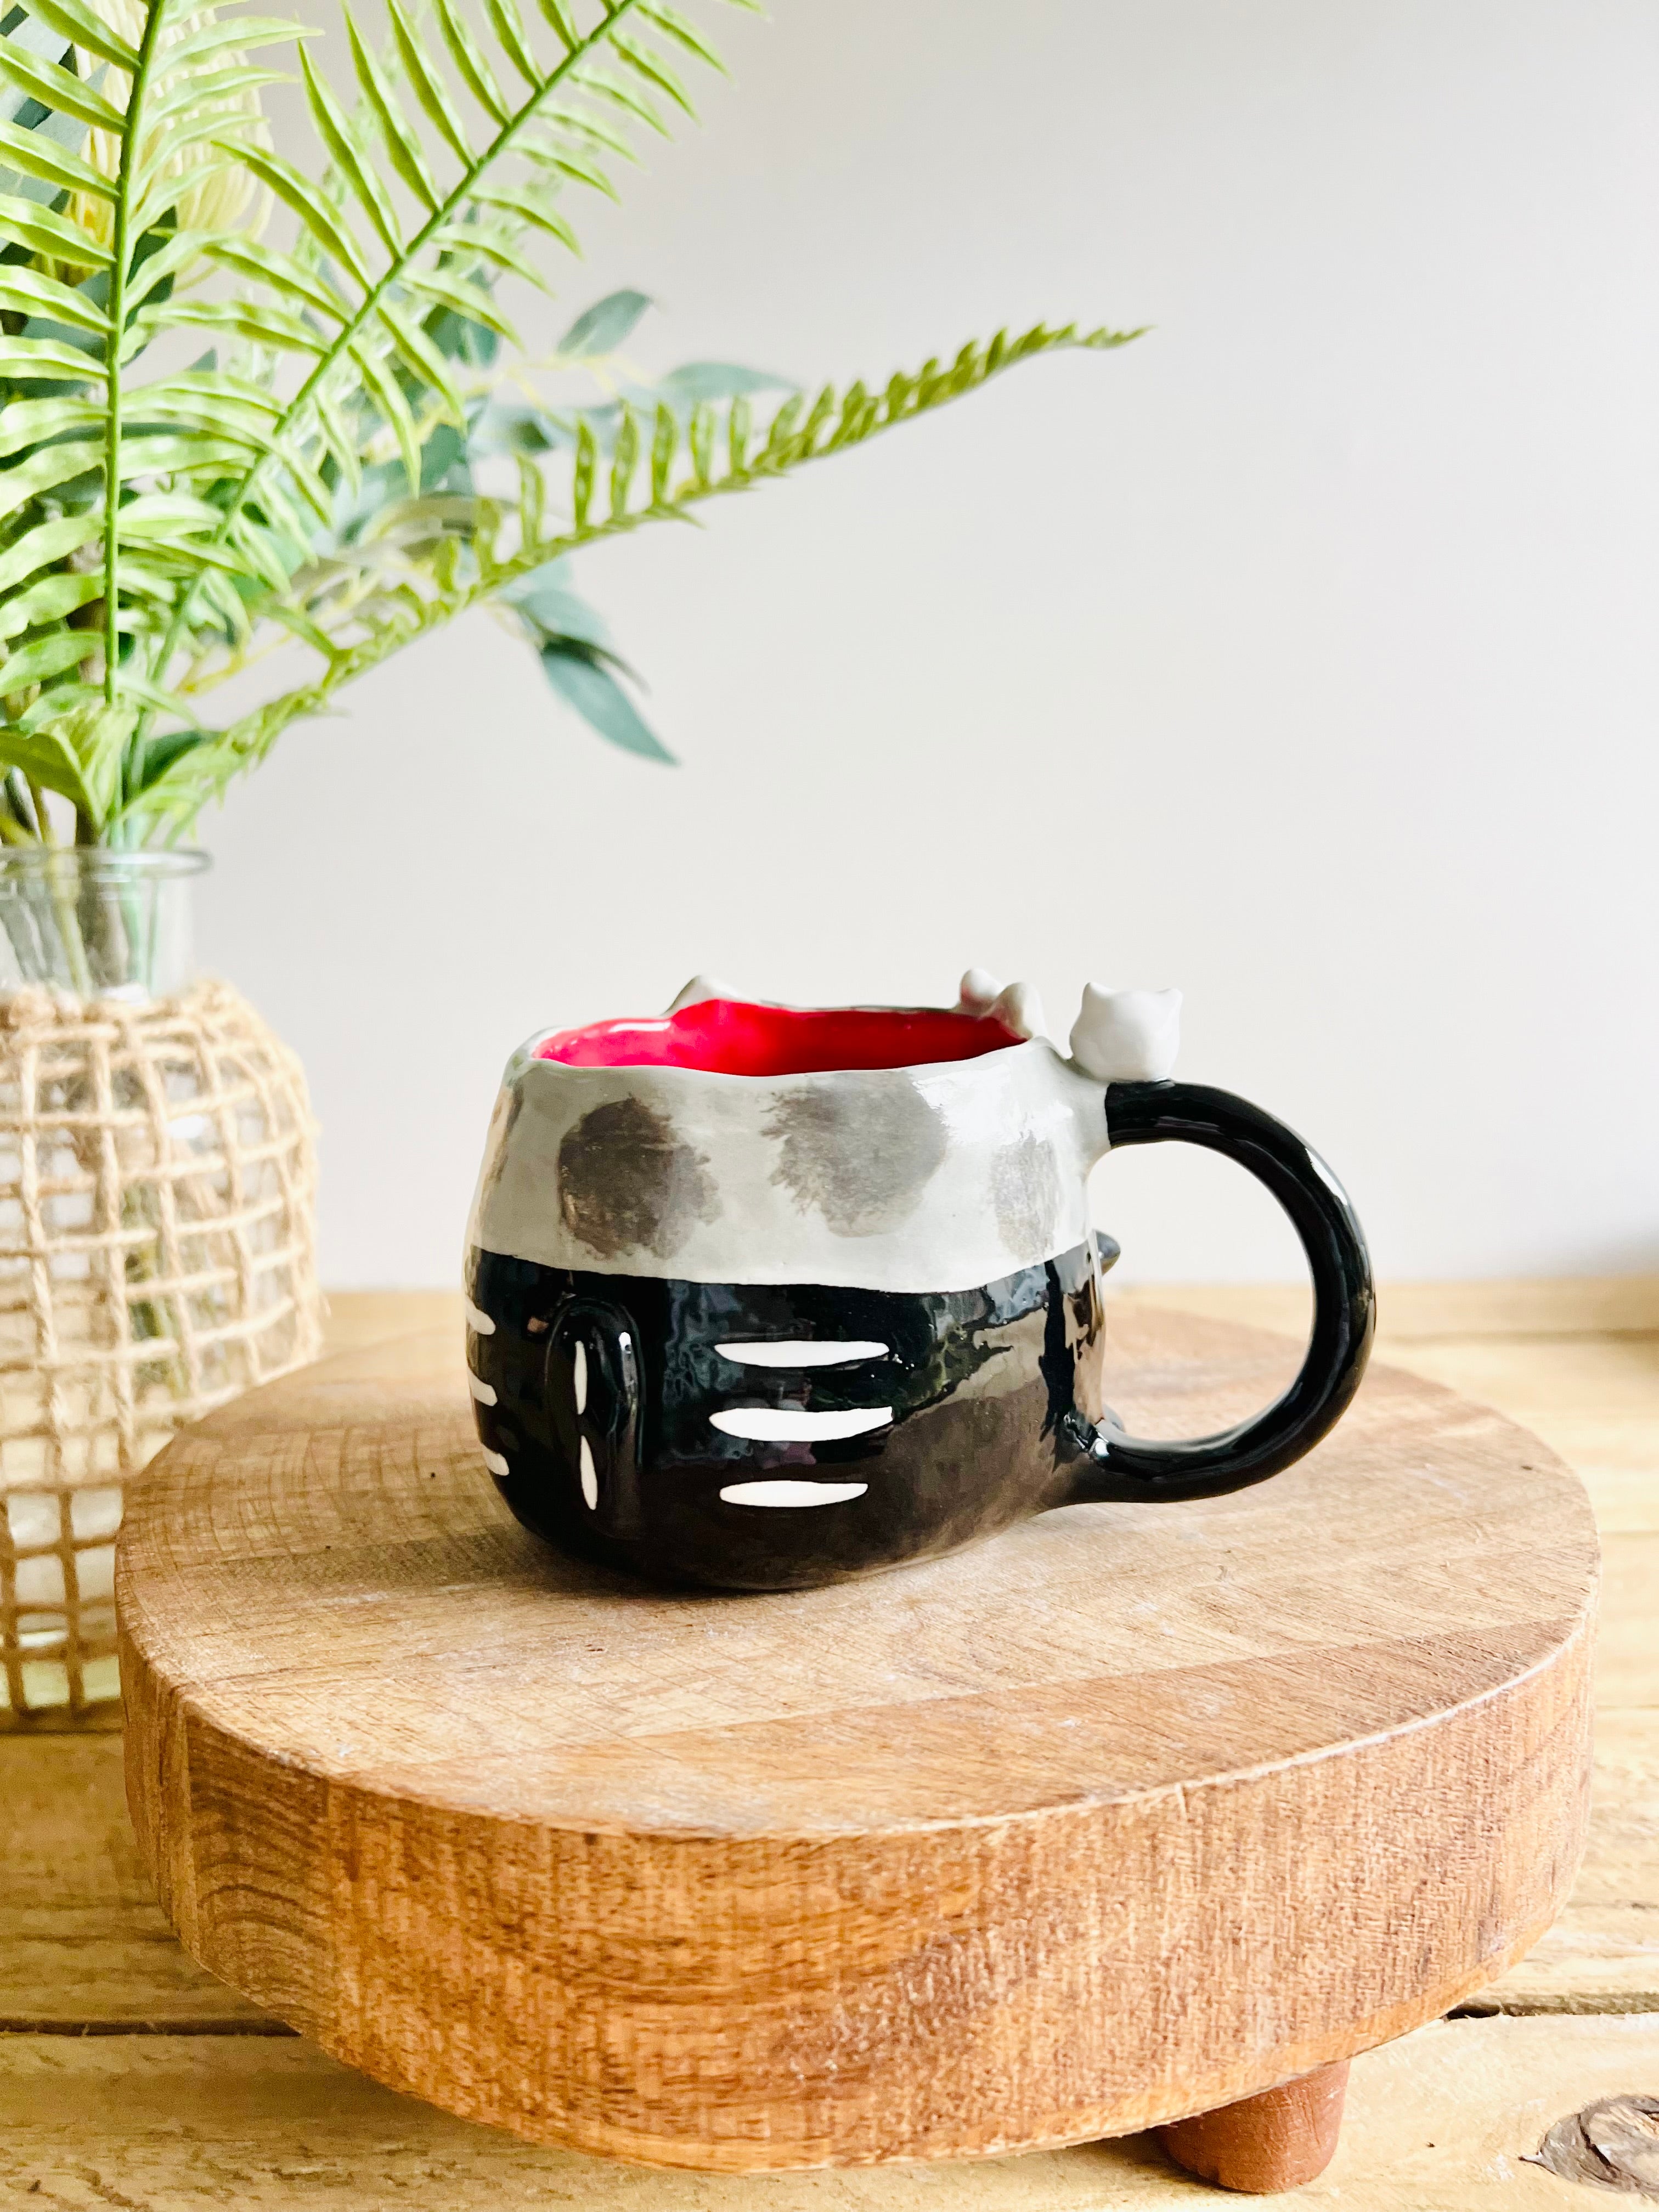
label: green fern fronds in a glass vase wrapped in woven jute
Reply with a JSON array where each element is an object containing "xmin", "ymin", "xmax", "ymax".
[{"xmin": 0, "ymin": 0, "xmax": 1128, "ymax": 1723}]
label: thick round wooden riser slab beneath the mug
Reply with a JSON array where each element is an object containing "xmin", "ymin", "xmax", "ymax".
[{"xmin": 117, "ymin": 1312, "xmax": 1597, "ymax": 2172}]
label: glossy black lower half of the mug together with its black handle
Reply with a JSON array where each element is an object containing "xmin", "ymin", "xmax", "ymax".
[{"xmin": 467, "ymin": 1084, "xmax": 1374, "ymax": 1590}]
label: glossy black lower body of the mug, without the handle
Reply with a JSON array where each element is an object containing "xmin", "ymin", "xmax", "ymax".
[{"xmin": 467, "ymin": 1239, "xmax": 1117, "ymax": 1590}]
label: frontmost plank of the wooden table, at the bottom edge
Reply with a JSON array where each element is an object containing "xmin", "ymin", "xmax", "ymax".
[{"xmin": 0, "ymin": 2026, "xmax": 1659, "ymax": 2212}]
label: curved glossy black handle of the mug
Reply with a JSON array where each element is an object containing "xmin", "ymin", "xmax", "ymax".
[{"xmin": 1073, "ymin": 1084, "xmax": 1376, "ymax": 1504}]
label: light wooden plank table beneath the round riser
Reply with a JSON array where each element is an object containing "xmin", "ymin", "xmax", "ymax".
[{"xmin": 0, "ymin": 1278, "xmax": 1659, "ymax": 2212}]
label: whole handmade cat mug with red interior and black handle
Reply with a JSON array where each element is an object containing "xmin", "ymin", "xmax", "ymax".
[{"xmin": 467, "ymin": 969, "xmax": 1374, "ymax": 1590}]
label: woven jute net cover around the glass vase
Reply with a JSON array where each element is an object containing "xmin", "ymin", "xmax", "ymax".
[{"xmin": 0, "ymin": 980, "xmax": 321, "ymax": 1728}]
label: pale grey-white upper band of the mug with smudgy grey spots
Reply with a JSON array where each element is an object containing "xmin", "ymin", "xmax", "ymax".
[{"xmin": 469, "ymin": 1037, "xmax": 1106, "ymax": 1292}]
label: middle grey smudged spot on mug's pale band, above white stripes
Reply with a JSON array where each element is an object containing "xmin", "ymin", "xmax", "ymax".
[{"xmin": 765, "ymin": 1075, "xmax": 945, "ymax": 1237}]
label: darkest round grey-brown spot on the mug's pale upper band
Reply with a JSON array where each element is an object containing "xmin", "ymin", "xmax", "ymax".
[{"xmin": 560, "ymin": 1099, "xmax": 719, "ymax": 1259}]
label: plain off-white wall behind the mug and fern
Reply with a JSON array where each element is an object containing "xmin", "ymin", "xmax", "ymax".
[{"xmin": 201, "ymin": 0, "xmax": 1659, "ymax": 1288}]
